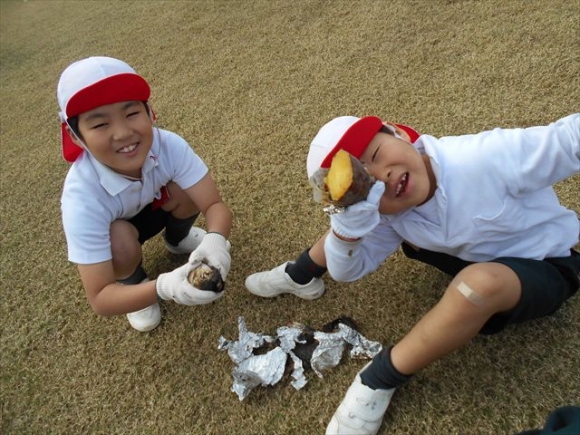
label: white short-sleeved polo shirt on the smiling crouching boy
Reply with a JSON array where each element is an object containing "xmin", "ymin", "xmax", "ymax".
[{"xmin": 61, "ymin": 128, "xmax": 208, "ymax": 264}]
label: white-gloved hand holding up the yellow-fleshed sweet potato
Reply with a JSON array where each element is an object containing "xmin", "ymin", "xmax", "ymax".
[{"xmin": 330, "ymin": 180, "xmax": 385, "ymax": 239}]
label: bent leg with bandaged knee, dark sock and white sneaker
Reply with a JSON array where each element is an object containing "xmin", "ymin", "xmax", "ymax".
[{"xmin": 326, "ymin": 263, "xmax": 521, "ymax": 435}]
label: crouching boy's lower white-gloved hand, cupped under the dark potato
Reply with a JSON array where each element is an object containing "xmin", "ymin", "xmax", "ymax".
[{"xmin": 155, "ymin": 263, "xmax": 224, "ymax": 305}]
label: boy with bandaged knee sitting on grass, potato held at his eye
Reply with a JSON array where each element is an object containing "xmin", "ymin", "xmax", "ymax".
[{"xmin": 246, "ymin": 114, "xmax": 580, "ymax": 434}]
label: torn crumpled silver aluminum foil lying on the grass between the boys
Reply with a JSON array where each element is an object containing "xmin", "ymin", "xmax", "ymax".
[{"xmin": 218, "ymin": 316, "xmax": 383, "ymax": 401}]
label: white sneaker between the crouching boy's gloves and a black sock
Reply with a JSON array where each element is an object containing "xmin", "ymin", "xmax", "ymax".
[{"xmin": 246, "ymin": 262, "xmax": 324, "ymax": 300}]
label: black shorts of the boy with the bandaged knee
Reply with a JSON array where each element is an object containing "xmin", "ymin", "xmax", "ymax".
[{"xmin": 402, "ymin": 243, "xmax": 580, "ymax": 334}]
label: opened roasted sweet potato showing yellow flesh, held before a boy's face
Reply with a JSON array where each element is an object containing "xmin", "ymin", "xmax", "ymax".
[{"xmin": 310, "ymin": 150, "xmax": 375, "ymax": 207}]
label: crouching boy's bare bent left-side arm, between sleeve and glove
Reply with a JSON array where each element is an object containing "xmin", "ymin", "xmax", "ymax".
[{"xmin": 78, "ymin": 260, "xmax": 157, "ymax": 317}]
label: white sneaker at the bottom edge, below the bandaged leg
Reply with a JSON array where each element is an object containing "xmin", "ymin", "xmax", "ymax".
[{"xmin": 326, "ymin": 363, "xmax": 396, "ymax": 435}]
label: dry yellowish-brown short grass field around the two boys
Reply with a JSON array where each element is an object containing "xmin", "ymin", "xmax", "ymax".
[{"xmin": 0, "ymin": 0, "xmax": 580, "ymax": 435}]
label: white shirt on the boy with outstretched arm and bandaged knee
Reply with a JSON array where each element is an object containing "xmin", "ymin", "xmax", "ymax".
[{"xmin": 325, "ymin": 114, "xmax": 580, "ymax": 281}]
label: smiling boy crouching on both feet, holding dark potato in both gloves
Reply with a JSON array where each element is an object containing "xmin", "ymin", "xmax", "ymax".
[{"xmin": 57, "ymin": 57, "xmax": 232, "ymax": 332}]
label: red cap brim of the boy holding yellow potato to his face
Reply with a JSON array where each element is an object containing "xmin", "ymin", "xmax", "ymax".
[{"xmin": 320, "ymin": 116, "xmax": 383, "ymax": 169}]
